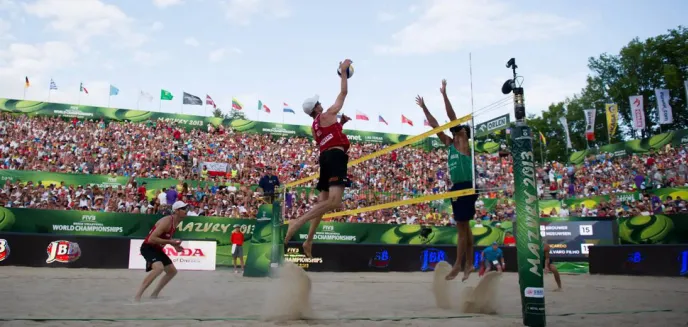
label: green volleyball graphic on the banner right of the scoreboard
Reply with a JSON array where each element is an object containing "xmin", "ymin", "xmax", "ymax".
[{"xmin": 619, "ymin": 215, "xmax": 674, "ymax": 244}]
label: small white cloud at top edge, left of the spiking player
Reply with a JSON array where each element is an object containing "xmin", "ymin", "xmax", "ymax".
[{"xmin": 223, "ymin": 0, "xmax": 291, "ymax": 25}]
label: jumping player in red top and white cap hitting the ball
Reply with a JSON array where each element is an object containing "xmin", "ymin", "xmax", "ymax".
[{"xmin": 284, "ymin": 59, "xmax": 351, "ymax": 257}]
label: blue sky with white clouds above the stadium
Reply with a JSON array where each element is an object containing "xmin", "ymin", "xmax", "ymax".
[{"xmin": 0, "ymin": 0, "xmax": 688, "ymax": 135}]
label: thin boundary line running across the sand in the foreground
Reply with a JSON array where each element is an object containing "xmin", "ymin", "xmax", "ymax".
[{"xmin": 0, "ymin": 309, "xmax": 676, "ymax": 322}]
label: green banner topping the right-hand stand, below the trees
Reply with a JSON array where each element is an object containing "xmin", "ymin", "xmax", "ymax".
[{"xmin": 569, "ymin": 129, "xmax": 688, "ymax": 165}]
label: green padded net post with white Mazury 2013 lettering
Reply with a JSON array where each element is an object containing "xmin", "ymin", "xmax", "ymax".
[{"xmin": 511, "ymin": 123, "xmax": 545, "ymax": 326}]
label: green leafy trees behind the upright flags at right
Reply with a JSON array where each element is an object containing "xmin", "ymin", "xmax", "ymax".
[{"xmin": 526, "ymin": 26, "xmax": 688, "ymax": 161}]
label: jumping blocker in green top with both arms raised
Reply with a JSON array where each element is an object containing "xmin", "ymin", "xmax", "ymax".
[{"xmin": 416, "ymin": 80, "xmax": 478, "ymax": 281}]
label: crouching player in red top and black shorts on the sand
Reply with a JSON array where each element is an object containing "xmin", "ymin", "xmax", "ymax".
[{"xmin": 134, "ymin": 201, "xmax": 189, "ymax": 301}]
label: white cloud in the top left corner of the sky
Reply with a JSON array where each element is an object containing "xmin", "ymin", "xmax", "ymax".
[{"xmin": 24, "ymin": 0, "xmax": 146, "ymax": 47}]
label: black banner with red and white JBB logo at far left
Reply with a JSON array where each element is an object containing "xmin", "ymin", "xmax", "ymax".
[{"xmin": 0, "ymin": 233, "xmax": 129, "ymax": 269}]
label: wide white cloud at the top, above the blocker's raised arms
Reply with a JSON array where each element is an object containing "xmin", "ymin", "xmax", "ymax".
[{"xmin": 375, "ymin": 0, "xmax": 583, "ymax": 54}]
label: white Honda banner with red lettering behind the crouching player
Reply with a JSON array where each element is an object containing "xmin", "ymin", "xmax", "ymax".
[{"xmin": 129, "ymin": 239, "xmax": 217, "ymax": 270}]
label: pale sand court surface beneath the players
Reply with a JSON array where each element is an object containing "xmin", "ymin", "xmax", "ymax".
[{"xmin": 0, "ymin": 267, "xmax": 688, "ymax": 327}]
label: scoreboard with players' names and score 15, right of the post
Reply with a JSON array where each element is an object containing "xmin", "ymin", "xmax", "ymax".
[{"xmin": 540, "ymin": 217, "xmax": 618, "ymax": 260}]
